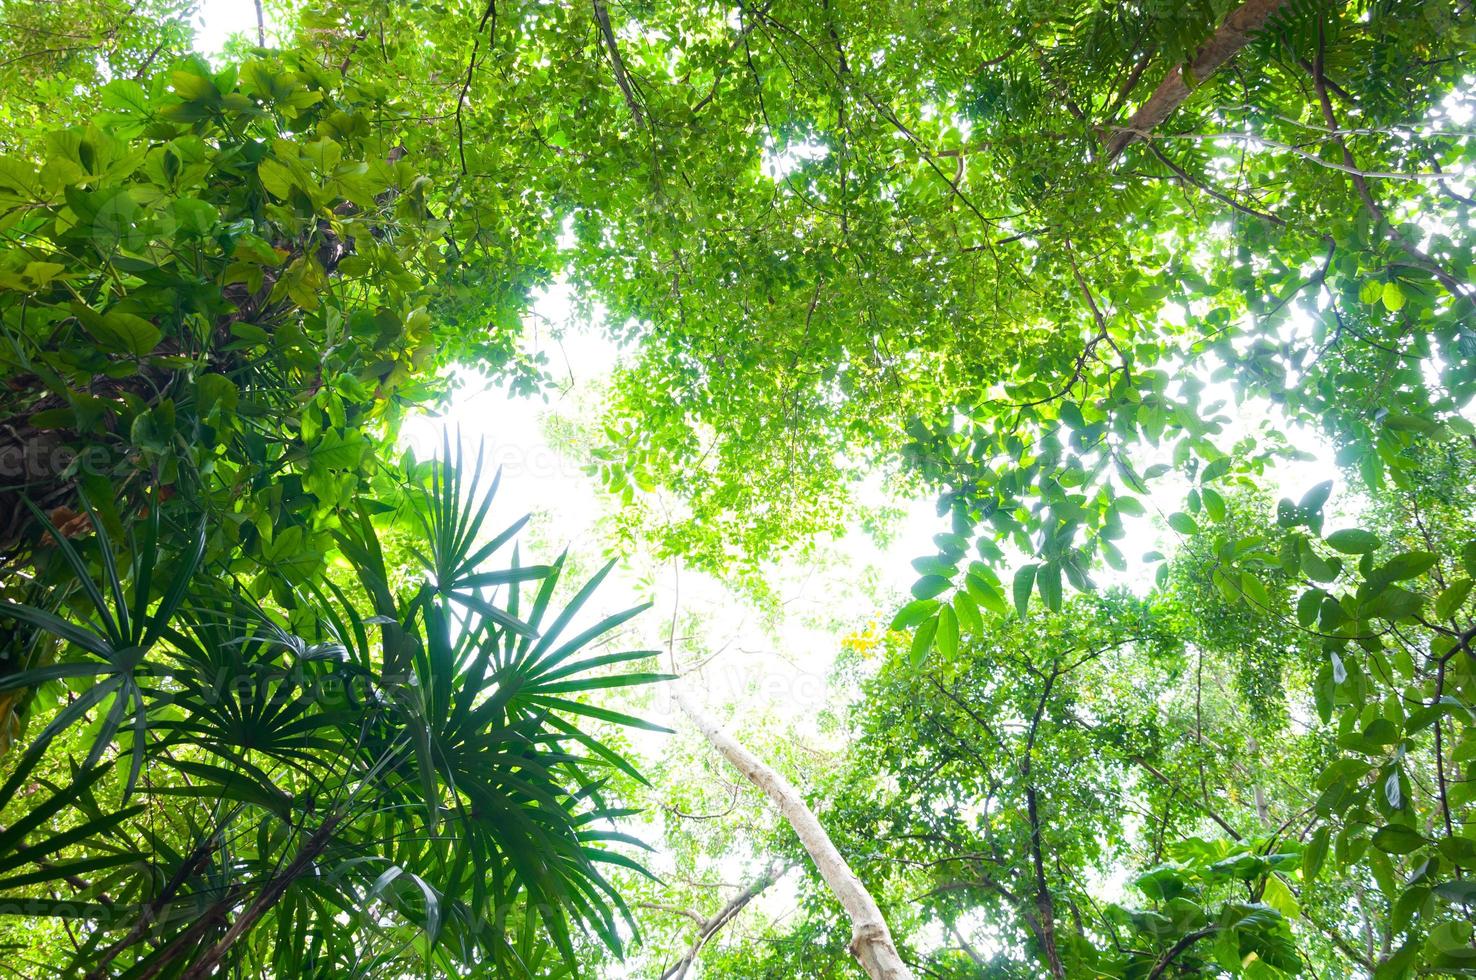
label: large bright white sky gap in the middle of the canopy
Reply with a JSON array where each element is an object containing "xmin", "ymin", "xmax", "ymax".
[{"xmin": 406, "ymin": 289, "xmax": 937, "ymax": 723}]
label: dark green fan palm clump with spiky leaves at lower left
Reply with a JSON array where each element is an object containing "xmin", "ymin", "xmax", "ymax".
[{"xmin": 0, "ymin": 446, "xmax": 661, "ymax": 977}]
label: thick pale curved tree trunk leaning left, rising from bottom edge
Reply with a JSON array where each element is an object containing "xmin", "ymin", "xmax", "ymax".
[{"xmin": 675, "ymin": 691, "xmax": 912, "ymax": 980}]
